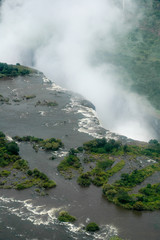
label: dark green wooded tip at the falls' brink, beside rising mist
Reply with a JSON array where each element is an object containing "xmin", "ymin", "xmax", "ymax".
[{"xmin": 0, "ymin": 63, "xmax": 35, "ymax": 78}]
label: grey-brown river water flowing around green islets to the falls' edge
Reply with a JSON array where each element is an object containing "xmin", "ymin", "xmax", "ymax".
[{"xmin": 0, "ymin": 74, "xmax": 160, "ymax": 240}]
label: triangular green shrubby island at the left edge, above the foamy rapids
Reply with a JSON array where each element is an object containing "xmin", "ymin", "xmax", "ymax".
[{"xmin": 0, "ymin": 132, "xmax": 56, "ymax": 192}]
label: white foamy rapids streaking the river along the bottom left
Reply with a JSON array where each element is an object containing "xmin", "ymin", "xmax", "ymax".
[{"xmin": 0, "ymin": 196, "xmax": 118, "ymax": 240}]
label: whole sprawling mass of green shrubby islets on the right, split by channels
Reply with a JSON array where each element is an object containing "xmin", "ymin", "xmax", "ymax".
[{"xmin": 80, "ymin": 139, "xmax": 160, "ymax": 210}]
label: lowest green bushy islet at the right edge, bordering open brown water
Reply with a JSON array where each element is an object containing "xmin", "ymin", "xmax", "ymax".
[{"xmin": 103, "ymin": 164, "xmax": 160, "ymax": 210}]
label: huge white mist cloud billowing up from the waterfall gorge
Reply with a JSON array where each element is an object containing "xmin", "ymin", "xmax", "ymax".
[{"xmin": 0, "ymin": 0, "xmax": 154, "ymax": 140}]
